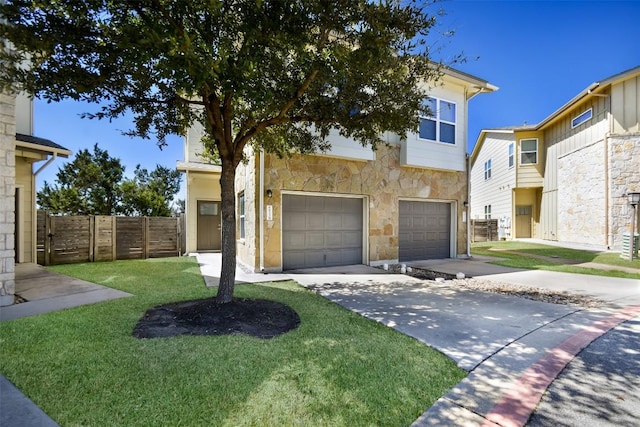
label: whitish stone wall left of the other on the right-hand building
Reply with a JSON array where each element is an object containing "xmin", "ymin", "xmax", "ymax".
[{"xmin": 558, "ymin": 141, "xmax": 607, "ymax": 245}]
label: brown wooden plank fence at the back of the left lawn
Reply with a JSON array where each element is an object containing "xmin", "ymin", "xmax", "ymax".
[{"xmin": 37, "ymin": 211, "xmax": 185, "ymax": 265}]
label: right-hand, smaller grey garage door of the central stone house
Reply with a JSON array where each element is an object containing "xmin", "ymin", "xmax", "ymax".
[{"xmin": 398, "ymin": 201, "xmax": 451, "ymax": 261}]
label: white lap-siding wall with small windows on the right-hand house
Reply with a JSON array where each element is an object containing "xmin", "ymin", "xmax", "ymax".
[{"xmin": 470, "ymin": 132, "xmax": 517, "ymax": 219}]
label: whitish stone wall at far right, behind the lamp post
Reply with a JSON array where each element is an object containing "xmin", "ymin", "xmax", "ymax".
[{"xmin": 607, "ymin": 133, "xmax": 640, "ymax": 251}]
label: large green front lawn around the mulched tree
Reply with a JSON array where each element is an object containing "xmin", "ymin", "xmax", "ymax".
[{"xmin": 0, "ymin": 258, "xmax": 465, "ymax": 426}]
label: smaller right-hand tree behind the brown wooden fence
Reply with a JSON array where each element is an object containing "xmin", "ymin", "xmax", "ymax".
[{"xmin": 120, "ymin": 165, "xmax": 181, "ymax": 216}]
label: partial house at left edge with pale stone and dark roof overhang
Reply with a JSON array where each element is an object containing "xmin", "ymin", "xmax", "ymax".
[{"xmin": 0, "ymin": 94, "xmax": 71, "ymax": 306}]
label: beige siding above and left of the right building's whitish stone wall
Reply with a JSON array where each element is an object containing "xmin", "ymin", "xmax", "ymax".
[{"xmin": 539, "ymin": 97, "xmax": 609, "ymax": 240}]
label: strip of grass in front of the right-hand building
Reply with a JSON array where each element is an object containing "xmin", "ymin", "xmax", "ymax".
[{"xmin": 471, "ymin": 241, "xmax": 640, "ymax": 279}]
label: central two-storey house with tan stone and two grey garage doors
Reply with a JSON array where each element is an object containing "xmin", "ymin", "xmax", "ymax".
[{"xmin": 178, "ymin": 68, "xmax": 497, "ymax": 272}]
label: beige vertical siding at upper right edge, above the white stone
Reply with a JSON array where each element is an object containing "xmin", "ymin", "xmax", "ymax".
[{"xmin": 611, "ymin": 77, "xmax": 640, "ymax": 134}]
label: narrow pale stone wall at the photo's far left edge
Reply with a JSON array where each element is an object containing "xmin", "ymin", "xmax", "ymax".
[{"xmin": 0, "ymin": 93, "xmax": 16, "ymax": 306}]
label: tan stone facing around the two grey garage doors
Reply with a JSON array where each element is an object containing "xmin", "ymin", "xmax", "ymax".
[{"xmin": 258, "ymin": 146, "xmax": 467, "ymax": 271}]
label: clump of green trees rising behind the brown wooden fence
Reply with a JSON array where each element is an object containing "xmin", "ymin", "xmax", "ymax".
[{"xmin": 37, "ymin": 144, "xmax": 180, "ymax": 216}]
